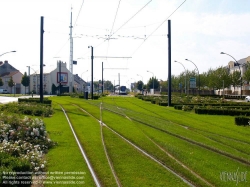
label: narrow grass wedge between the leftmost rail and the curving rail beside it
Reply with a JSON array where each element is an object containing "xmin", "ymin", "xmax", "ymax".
[{"xmin": 59, "ymin": 104, "xmax": 116, "ymax": 186}]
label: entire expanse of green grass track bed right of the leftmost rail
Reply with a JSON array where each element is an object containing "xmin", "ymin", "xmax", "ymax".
[{"xmin": 46, "ymin": 97, "xmax": 250, "ymax": 186}]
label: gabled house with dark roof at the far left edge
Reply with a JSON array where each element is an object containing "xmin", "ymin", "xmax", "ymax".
[{"xmin": 0, "ymin": 61, "xmax": 25, "ymax": 94}]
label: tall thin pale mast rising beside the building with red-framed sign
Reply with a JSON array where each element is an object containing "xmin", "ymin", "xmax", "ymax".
[{"xmin": 69, "ymin": 8, "xmax": 73, "ymax": 93}]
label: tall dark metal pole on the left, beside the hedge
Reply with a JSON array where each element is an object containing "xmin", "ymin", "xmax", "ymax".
[{"xmin": 40, "ymin": 16, "xmax": 44, "ymax": 103}]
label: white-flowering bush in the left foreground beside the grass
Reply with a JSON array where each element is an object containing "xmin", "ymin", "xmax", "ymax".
[{"xmin": 0, "ymin": 114, "xmax": 55, "ymax": 171}]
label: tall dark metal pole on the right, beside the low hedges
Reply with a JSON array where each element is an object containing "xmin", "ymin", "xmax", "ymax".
[{"xmin": 168, "ymin": 20, "xmax": 172, "ymax": 106}]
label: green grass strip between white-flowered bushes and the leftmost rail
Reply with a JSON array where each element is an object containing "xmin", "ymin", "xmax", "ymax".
[{"xmin": 43, "ymin": 104, "xmax": 94, "ymax": 187}]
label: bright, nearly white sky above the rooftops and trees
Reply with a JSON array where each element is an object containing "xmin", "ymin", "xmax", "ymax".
[{"xmin": 0, "ymin": 0, "xmax": 250, "ymax": 86}]
